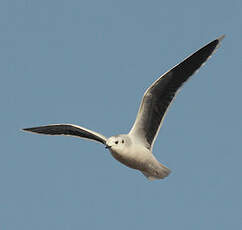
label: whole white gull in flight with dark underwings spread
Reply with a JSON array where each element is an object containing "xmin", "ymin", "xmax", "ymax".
[{"xmin": 23, "ymin": 35, "xmax": 224, "ymax": 180}]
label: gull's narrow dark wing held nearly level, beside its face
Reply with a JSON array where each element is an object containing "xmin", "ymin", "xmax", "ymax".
[{"xmin": 23, "ymin": 124, "xmax": 107, "ymax": 144}]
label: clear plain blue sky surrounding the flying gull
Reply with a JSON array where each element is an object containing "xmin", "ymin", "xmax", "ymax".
[{"xmin": 0, "ymin": 0, "xmax": 242, "ymax": 230}]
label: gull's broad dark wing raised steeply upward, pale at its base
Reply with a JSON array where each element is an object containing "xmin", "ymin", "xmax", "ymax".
[{"xmin": 130, "ymin": 35, "xmax": 224, "ymax": 149}]
